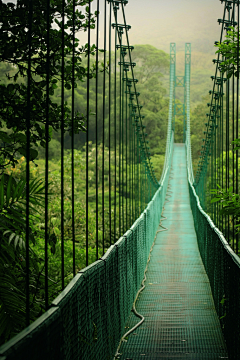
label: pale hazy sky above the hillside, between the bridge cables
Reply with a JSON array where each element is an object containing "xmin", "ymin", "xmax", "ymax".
[{"xmin": 117, "ymin": 0, "xmax": 224, "ymax": 52}]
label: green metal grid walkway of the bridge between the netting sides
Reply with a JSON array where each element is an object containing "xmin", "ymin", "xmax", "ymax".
[{"xmin": 120, "ymin": 144, "xmax": 228, "ymax": 360}]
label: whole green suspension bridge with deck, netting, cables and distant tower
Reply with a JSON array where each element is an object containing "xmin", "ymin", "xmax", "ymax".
[{"xmin": 0, "ymin": 0, "xmax": 240, "ymax": 360}]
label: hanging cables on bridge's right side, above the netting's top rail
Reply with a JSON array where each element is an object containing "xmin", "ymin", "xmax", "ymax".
[{"xmin": 194, "ymin": 1, "xmax": 239, "ymax": 254}]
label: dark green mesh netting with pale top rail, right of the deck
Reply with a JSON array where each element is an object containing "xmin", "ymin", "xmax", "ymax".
[{"xmin": 189, "ymin": 183, "xmax": 240, "ymax": 359}]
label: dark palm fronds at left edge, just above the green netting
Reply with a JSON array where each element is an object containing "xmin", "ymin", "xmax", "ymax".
[{"xmin": 0, "ymin": 174, "xmax": 45, "ymax": 341}]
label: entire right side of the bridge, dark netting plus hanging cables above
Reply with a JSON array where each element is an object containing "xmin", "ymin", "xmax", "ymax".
[{"xmin": 186, "ymin": 1, "xmax": 240, "ymax": 360}]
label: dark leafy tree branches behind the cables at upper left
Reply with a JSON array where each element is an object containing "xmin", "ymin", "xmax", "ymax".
[{"xmin": 0, "ymin": 0, "xmax": 102, "ymax": 169}]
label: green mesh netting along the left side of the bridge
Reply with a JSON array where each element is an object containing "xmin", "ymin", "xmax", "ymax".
[{"xmin": 0, "ymin": 136, "xmax": 173, "ymax": 360}]
